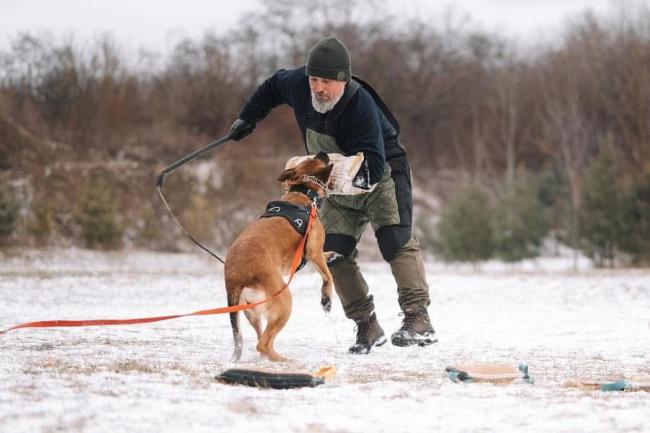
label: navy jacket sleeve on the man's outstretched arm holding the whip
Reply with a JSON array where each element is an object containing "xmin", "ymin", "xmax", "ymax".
[{"xmin": 239, "ymin": 69, "xmax": 297, "ymax": 124}]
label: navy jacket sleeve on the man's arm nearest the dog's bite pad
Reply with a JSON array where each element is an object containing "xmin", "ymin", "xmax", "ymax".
[{"xmin": 341, "ymin": 91, "xmax": 386, "ymax": 184}]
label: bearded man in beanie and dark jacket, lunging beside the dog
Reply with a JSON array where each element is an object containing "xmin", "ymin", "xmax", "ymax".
[{"xmin": 230, "ymin": 37, "xmax": 437, "ymax": 354}]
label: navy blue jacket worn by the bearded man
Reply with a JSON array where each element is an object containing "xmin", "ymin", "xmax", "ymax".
[{"xmin": 239, "ymin": 66, "xmax": 397, "ymax": 184}]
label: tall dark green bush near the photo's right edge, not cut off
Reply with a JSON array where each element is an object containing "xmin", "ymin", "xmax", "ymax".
[{"xmin": 578, "ymin": 146, "xmax": 632, "ymax": 266}]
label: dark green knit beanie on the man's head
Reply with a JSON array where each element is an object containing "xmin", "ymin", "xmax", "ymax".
[{"xmin": 305, "ymin": 37, "xmax": 352, "ymax": 81}]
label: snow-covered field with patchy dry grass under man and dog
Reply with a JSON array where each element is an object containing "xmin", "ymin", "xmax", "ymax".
[{"xmin": 0, "ymin": 249, "xmax": 650, "ymax": 433}]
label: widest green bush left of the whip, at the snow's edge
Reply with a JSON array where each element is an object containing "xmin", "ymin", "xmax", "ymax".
[{"xmin": 76, "ymin": 181, "xmax": 122, "ymax": 248}]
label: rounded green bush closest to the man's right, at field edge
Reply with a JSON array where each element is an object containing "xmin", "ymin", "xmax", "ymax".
[{"xmin": 434, "ymin": 186, "xmax": 494, "ymax": 262}]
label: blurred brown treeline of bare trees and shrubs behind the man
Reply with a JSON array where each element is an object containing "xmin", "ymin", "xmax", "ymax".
[{"xmin": 0, "ymin": 0, "xmax": 650, "ymax": 265}]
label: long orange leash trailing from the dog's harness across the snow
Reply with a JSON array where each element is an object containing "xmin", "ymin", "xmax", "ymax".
[{"xmin": 0, "ymin": 205, "xmax": 316, "ymax": 334}]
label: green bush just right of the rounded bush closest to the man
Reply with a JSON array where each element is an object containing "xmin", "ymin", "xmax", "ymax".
[{"xmin": 494, "ymin": 176, "xmax": 551, "ymax": 262}]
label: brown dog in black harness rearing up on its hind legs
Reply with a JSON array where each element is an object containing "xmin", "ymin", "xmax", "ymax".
[{"xmin": 224, "ymin": 153, "xmax": 333, "ymax": 361}]
